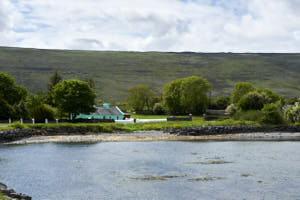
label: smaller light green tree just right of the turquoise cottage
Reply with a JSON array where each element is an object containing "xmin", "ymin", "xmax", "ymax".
[{"xmin": 126, "ymin": 85, "xmax": 154, "ymax": 111}]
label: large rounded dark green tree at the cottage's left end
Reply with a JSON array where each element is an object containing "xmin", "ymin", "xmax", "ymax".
[{"xmin": 52, "ymin": 79, "xmax": 96, "ymax": 116}]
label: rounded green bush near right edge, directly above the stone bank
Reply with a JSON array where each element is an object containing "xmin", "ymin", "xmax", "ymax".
[{"xmin": 262, "ymin": 103, "xmax": 283, "ymax": 124}]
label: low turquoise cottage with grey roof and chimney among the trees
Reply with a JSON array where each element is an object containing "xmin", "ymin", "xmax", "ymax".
[{"xmin": 75, "ymin": 103, "xmax": 124, "ymax": 120}]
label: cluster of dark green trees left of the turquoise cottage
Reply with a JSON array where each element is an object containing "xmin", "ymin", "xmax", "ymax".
[{"xmin": 0, "ymin": 72, "xmax": 96, "ymax": 122}]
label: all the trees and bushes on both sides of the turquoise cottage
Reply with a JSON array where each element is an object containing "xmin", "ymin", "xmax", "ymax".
[{"xmin": 0, "ymin": 72, "xmax": 300, "ymax": 124}]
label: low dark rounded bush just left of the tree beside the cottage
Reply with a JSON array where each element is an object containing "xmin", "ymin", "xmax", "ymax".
[{"xmin": 31, "ymin": 104, "xmax": 55, "ymax": 122}]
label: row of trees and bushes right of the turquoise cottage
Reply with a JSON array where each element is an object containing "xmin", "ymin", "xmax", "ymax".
[{"xmin": 126, "ymin": 76, "xmax": 300, "ymax": 124}]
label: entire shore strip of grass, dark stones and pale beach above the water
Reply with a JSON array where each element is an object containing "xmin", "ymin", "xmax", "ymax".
[{"xmin": 0, "ymin": 115, "xmax": 300, "ymax": 144}]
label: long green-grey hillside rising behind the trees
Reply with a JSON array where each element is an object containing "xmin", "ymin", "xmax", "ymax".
[{"xmin": 0, "ymin": 47, "xmax": 300, "ymax": 101}]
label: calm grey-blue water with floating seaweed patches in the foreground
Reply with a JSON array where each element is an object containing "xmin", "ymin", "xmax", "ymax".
[{"xmin": 0, "ymin": 142, "xmax": 300, "ymax": 200}]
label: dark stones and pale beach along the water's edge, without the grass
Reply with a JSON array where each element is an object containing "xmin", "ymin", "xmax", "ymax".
[{"xmin": 0, "ymin": 126, "xmax": 300, "ymax": 144}]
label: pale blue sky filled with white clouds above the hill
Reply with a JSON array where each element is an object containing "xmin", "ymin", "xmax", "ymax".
[{"xmin": 0, "ymin": 0, "xmax": 300, "ymax": 53}]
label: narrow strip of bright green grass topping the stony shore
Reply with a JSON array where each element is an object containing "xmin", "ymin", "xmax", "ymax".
[{"xmin": 3, "ymin": 117, "xmax": 259, "ymax": 133}]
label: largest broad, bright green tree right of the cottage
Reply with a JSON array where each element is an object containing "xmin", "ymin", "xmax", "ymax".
[{"xmin": 162, "ymin": 76, "xmax": 211, "ymax": 114}]
